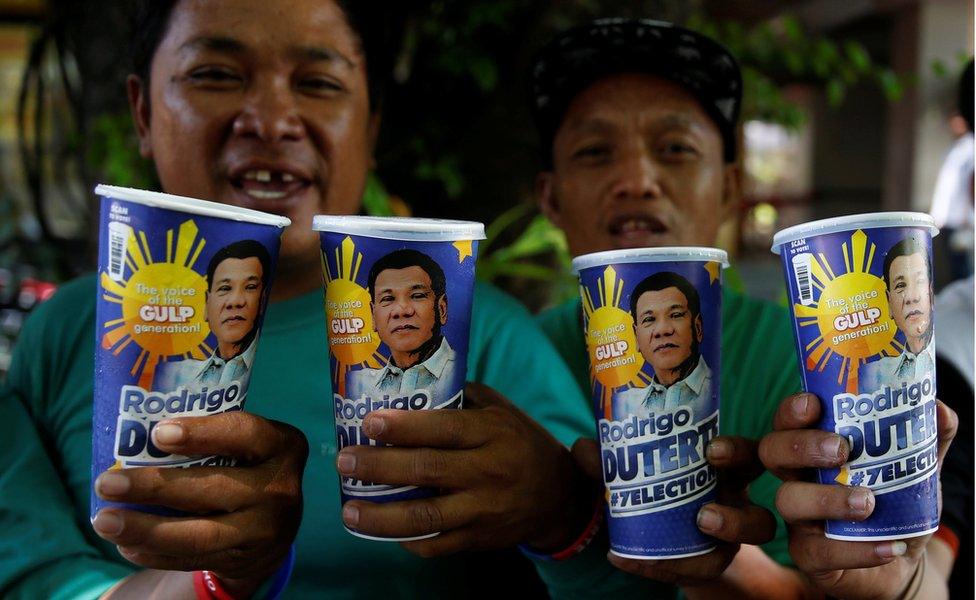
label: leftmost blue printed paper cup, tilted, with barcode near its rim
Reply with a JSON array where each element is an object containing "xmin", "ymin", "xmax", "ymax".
[{"xmin": 91, "ymin": 185, "xmax": 290, "ymax": 518}]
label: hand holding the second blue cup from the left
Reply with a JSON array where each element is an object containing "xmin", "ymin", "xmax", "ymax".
[{"xmin": 336, "ymin": 383, "xmax": 598, "ymax": 557}]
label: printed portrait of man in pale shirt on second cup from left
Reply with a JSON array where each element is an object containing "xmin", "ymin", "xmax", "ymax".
[{"xmin": 346, "ymin": 249, "xmax": 456, "ymax": 404}]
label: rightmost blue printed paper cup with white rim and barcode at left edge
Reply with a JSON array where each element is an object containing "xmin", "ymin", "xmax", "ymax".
[{"xmin": 773, "ymin": 212, "xmax": 939, "ymax": 541}]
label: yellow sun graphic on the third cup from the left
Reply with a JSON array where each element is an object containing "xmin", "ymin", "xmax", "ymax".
[{"xmin": 580, "ymin": 266, "xmax": 650, "ymax": 419}]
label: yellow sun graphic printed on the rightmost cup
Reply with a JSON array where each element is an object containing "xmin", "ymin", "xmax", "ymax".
[{"xmin": 793, "ymin": 230, "xmax": 901, "ymax": 393}]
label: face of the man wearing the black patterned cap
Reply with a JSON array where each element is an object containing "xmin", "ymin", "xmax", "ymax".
[{"xmin": 536, "ymin": 74, "xmax": 737, "ymax": 256}]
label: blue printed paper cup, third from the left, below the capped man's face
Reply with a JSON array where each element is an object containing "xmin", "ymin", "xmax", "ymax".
[{"xmin": 573, "ymin": 247, "xmax": 728, "ymax": 559}]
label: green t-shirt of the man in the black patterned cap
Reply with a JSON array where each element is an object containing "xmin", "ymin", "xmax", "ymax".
[{"xmin": 536, "ymin": 290, "xmax": 800, "ymax": 565}]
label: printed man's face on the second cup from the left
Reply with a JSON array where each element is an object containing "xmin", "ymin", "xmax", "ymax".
[{"xmin": 373, "ymin": 266, "xmax": 447, "ymax": 369}]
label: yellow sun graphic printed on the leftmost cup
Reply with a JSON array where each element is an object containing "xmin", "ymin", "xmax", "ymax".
[{"xmin": 99, "ymin": 220, "xmax": 213, "ymax": 389}]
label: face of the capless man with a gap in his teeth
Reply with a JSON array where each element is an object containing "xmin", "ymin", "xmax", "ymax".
[{"xmin": 129, "ymin": 0, "xmax": 374, "ymax": 288}]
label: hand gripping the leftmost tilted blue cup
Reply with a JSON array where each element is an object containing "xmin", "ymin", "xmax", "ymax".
[{"xmin": 92, "ymin": 411, "xmax": 308, "ymax": 593}]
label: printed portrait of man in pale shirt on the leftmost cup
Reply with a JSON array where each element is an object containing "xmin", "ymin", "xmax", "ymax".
[{"xmin": 153, "ymin": 240, "xmax": 271, "ymax": 392}]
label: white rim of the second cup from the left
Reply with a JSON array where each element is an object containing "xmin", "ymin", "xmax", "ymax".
[{"xmin": 312, "ymin": 215, "xmax": 485, "ymax": 242}]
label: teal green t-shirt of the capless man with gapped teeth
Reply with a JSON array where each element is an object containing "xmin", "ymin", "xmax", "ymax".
[{"xmin": 0, "ymin": 276, "xmax": 672, "ymax": 599}]
